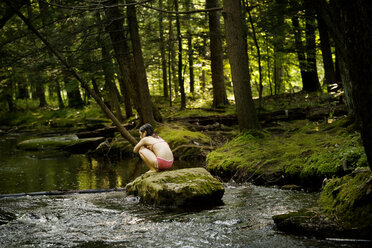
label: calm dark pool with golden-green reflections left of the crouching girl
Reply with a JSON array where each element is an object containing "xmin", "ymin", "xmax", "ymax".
[{"xmin": 0, "ymin": 136, "xmax": 147, "ymax": 194}]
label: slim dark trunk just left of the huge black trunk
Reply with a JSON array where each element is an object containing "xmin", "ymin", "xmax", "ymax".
[{"xmin": 317, "ymin": 12, "xmax": 337, "ymax": 92}]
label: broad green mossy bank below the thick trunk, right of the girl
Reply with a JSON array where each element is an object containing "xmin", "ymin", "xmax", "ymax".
[{"xmin": 207, "ymin": 118, "xmax": 367, "ymax": 188}]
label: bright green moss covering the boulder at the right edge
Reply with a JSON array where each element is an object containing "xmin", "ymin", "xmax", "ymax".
[{"xmin": 319, "ymin": 168, "xmax": 372, "ymax": 230}]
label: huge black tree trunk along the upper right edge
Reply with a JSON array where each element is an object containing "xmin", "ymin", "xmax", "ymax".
[{"xmin": 316, "ymin": 0, "xmax": 372, "ymax": 169}]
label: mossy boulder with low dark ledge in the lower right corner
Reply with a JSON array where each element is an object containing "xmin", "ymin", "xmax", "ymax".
[{"xmin": 273, "ymin": 168, "xmax": 372, "ymax": 239}]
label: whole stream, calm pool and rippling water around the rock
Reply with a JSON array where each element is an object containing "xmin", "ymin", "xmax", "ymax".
[{"xmin": 0, "ymin": 135, "xmax": 363, "ymax": 247}]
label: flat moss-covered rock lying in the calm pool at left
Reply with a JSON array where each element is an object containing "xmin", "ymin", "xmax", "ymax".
[{"xmin": 17, "ymin": 135, "xmax": 79, "ymax": 150}]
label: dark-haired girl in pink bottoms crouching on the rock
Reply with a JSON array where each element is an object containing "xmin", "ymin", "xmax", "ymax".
[{"xmin": 133, "ymin": 123, "xmax": 174, "ymax": 172}]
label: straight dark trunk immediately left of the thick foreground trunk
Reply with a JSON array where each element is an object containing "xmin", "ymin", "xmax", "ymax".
[{"xmin": 206, "ymin": 0, "xmax": 228, "ymax": 108}]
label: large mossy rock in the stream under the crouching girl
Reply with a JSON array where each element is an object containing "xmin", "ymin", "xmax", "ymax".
[{"xmin": 126, "ymin": 168, "xmax": 225, "ymax": 208}]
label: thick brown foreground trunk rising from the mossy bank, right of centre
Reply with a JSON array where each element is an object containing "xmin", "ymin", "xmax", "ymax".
[{"xmin": 223, "ymin": 0, "xmax": 260, "ymax": 129}]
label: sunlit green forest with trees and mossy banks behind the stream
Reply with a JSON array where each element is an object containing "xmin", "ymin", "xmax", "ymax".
[{"xmin": 0, "ymin": 0, "xmax": 372, "ymax": 244}]
